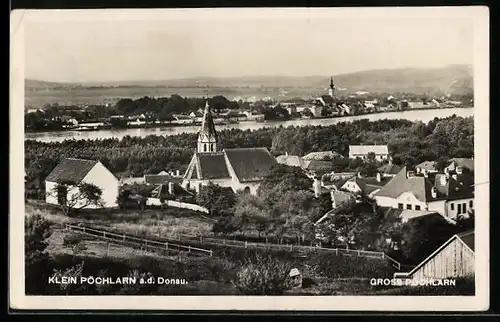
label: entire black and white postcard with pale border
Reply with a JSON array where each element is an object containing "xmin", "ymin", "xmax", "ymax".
[{"xmin": 9, "ymin": 6, "xmax": 490, "ymax": 311}]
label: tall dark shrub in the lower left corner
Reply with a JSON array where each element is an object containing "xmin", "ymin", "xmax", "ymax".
[{"xmin": 24, "ymin": 214, "xmax": 52, "ymax": 295}]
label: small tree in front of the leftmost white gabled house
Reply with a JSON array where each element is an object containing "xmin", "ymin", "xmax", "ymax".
[{"xmin": 49, "ymin": 181, "xmax": 103, "ymax": 216}]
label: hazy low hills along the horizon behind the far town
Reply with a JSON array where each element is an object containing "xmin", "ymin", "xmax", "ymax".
[{"xmin": 25, "ymin": 65, "xmax": 473, "ymax": 94}]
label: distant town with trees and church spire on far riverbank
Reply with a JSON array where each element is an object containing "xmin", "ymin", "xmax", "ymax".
[{"xmin": 25, "ymin": 78, "xmax": 474, "ymax": 131}]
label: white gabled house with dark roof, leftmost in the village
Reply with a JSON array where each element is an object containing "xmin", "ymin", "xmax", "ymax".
[{"xmin": 45, "ymin": 158, "xmax": 119, "ymax": 208}]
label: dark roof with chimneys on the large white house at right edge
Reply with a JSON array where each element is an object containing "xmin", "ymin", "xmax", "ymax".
[{"xmin": 434, "ymin": 173, "xmax": 474, "ymax": 200}]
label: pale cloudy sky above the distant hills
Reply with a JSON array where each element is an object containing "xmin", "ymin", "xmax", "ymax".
[{"xmin": 23, "ymin": 8, "xmax": 474, "ymax": 82}]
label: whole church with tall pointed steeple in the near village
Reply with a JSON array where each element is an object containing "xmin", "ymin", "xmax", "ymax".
[{"xmin": 182, "ymin": 101, "xmax": 277, "ymax": 194}]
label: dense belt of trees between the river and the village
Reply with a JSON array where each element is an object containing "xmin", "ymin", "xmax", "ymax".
[{"xmin": 25, "ymin": 116, "xmax": 474, "ymax": 199}]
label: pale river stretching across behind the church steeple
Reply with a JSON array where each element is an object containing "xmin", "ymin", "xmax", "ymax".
[{"xmin": 24, "ymin": 108, "xmax": 474, "ymax": 142}]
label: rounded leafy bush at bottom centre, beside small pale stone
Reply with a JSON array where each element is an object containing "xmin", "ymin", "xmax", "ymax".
[{"xmin": 233, "ymin": 255, "xmax": 291, "ymax": 295}]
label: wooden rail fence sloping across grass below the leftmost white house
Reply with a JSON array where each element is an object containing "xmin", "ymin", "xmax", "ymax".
[{"xmin": 66, "ymin": 224, "xmax": 213, "ymax": 256}]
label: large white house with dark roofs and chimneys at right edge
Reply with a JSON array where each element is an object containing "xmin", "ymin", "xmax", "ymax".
[{"xmin": 374, "ymin": 167, "xmax": 474, "ymax": 220}]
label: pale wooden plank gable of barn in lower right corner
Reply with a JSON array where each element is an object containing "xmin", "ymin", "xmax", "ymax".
[{"xmin": 394, "ymin": 230, "xmax": 475, "ymax": 281}]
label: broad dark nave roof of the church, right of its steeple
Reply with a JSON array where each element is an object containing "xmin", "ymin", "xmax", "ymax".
[{"xmin": 224, "ymin": 148, "xmax": 277, "ymax": 182}]
